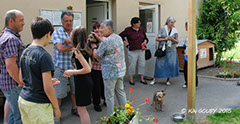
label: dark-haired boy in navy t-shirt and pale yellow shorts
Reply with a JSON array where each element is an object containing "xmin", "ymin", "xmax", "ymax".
[{"xmin": 18, "ymin": 17, "xmax": 61, "ymax": 124}]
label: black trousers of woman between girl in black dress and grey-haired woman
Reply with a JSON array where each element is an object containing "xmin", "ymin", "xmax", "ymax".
[{"xmin": 91, "ymin": 69, "xmax": 105, "ymax": 105}]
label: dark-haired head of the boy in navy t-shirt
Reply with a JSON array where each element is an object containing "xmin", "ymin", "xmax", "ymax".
[{"xmin": 31, "ymin": 16, "xmax": 54, "ymax": 45}]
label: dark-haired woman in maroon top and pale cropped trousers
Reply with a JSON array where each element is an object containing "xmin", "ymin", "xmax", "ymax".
[{"xmin": 119, "ymin": 17, "xmax": 148, "ymax": 85}]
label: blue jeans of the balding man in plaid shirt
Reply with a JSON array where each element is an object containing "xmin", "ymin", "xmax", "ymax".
[{"xmin": 3, "ymin": 87, "xmax": 22, "ymax": 124}]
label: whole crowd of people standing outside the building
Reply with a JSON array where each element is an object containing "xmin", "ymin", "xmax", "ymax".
[{"xmin": 0, "ymin": 10, "xmax": 199, "ymax": 124}]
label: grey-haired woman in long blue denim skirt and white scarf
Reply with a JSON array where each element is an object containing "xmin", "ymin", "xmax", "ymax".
[{"xmin": 150, "ymin": 17, "xmax": 179, "ymax": 85}]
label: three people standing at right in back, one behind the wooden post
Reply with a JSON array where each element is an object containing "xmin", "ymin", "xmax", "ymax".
[{"xmin": 119, "ymin": 17, "xmax": 198, "ymax": 87}]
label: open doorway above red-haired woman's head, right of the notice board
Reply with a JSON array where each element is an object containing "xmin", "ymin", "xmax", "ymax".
[{"xmin": 87, "ymin": 0, "xmax": 112, "ymax": 34}]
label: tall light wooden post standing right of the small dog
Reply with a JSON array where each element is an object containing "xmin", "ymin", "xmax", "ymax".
[{"xmin": 187, "ymin": 0, "xmax": 196, "ymax": 122}]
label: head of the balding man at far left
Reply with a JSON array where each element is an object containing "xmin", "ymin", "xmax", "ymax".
[{"xmin": 5, "ymin": 9, "xmax": 25, "ymax": 33}]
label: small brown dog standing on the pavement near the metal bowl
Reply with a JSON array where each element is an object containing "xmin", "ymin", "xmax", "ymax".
[{"xmin": 152, "ymin": 91, "xmax": 166, "ymax": 111}]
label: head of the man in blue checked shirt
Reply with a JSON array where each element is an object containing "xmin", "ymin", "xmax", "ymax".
[{"xmin": 61, "ymin": 11, "xmax": 74, "ymax": 31}]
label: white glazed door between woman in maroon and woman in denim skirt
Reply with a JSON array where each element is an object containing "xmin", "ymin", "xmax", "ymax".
[{"xmin": 139, "ymin": 5, "xmax": 159, "ymax": 77}]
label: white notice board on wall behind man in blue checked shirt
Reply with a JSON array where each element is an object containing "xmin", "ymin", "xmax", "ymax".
[{"xmin": 40, "ymin": 9, "xmax": 82, "ymax": 28}]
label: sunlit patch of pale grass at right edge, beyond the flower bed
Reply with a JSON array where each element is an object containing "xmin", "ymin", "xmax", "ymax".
[{"xmin": 223, "ymin": 45, "xmax": 240, "ymax": 59}]
